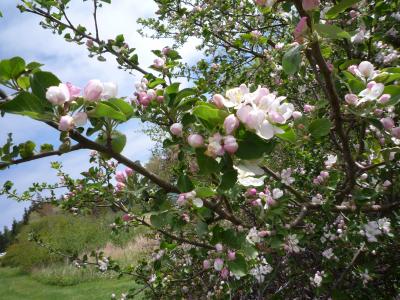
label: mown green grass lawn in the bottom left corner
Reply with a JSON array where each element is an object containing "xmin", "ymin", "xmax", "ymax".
[{"xmin": 0, "ymin": 268, "xmax": 142, "ymax": 300}]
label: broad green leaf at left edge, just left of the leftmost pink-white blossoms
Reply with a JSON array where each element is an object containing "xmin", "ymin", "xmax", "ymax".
[{"xmin": 0, "ymin": 92, "xmax": 47, "ymax": 119}]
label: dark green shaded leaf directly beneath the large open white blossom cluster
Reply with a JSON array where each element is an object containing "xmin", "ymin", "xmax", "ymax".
[{"xmin": 235, "ymin": 131, "xmax": 276, "ymax": 159}]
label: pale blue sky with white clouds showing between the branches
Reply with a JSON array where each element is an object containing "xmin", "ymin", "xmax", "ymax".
[{"xmin": 0, "ymin": 0, "xmax": 201, "ymax": 230}]
